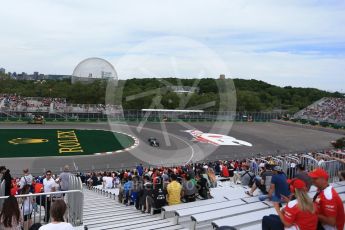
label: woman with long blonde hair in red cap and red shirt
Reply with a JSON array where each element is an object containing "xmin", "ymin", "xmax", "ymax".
[{"xmin": 262, "ymin": 179, "xmax": 318, "ymax": 230}]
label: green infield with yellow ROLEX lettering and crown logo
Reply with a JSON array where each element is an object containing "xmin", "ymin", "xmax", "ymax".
[{"xmin": 0, "ymin": 129, "xmax": 135, "ymax": 158}]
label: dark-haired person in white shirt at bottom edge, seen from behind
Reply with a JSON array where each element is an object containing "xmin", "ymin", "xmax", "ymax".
[{"xmin": 39, "ymin": 200, "xmax": 74, "ymax": 230}]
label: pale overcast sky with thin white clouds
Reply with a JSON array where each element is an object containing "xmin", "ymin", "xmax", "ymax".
[{"xmin": 0, "ymin": 0, "xmax": 345, "ymax": 91}]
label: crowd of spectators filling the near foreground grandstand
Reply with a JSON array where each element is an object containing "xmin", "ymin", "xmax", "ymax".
[{"xmin": 0, "ymin": 151, "xmax": 344, "ymax": 230}]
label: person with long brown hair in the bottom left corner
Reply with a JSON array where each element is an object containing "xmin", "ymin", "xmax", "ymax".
[{"xmin": 0, "ymin": 196, "xmax": 23, "ymax": 230}]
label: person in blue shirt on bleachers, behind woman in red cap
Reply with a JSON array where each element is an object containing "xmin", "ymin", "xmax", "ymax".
[{"xmin": 259, "ymin": 166, "xmax": 290, "ymax": 203}]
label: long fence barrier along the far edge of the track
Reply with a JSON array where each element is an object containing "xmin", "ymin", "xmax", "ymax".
[{"xmin": 0, "ymin": 109, "xmax": 282, "ymax": 122}]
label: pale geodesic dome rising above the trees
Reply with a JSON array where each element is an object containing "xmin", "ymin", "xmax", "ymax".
[{"xmin": 72, "ymin": 57, "xmax": 117, "ymax": 83}]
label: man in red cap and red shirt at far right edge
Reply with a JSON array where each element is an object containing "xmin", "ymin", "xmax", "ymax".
[{"xmin": 309, "ymin": 168, "xmax": 345, "ymax": 230}]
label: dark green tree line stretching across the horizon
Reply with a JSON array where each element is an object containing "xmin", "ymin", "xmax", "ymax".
[{"xmin": 0, "ymin": 74, "xmax": 343, "ymax": 113}]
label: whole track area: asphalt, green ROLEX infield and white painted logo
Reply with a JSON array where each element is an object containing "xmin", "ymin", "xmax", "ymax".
[{"xmin": 0, "ymin": 122, "xmax": 344, "ymax": 175}]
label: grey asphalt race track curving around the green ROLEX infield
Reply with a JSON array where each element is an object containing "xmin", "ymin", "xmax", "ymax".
[{"xmin": 0, "ymin": 122, "xmax": 343, "ymax": 175}]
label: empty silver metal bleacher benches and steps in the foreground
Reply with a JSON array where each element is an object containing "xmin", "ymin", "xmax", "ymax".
[{"xmin": 84, "ymin": 182, "xmax": 345, "ymax": 230}]
